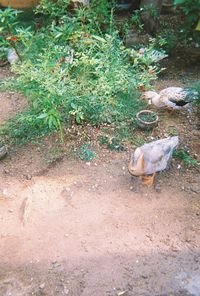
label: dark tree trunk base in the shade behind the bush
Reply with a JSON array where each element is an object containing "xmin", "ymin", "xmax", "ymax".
[{"xmin": 140, "ymin": 0, "xmax": 163, "ymax": 36}]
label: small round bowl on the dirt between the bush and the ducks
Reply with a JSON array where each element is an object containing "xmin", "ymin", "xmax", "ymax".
[{"xmin": 136, "ymin": 110, "xmax": 159, "ymax": 130}]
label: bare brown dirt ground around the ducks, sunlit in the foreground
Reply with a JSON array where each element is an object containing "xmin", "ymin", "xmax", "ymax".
[{"xmin": 0, "ymin": 58, "xmax": 200, "ymax": 296}]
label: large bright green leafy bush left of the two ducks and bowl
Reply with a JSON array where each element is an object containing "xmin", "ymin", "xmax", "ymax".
[{"xmin": 0, "ymin": 5, "xmax": 162, "ymax": 141}]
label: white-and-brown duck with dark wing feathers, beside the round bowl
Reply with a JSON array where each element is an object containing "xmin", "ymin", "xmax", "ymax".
[{"xmin": 142, "ymin": 87, "xmax": 198, "ymax": 110}]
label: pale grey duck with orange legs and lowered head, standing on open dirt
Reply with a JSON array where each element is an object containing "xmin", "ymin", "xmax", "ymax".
[{"xmin": 128, "ymin": 136, "xmax": 179, "ymax": 186}]
